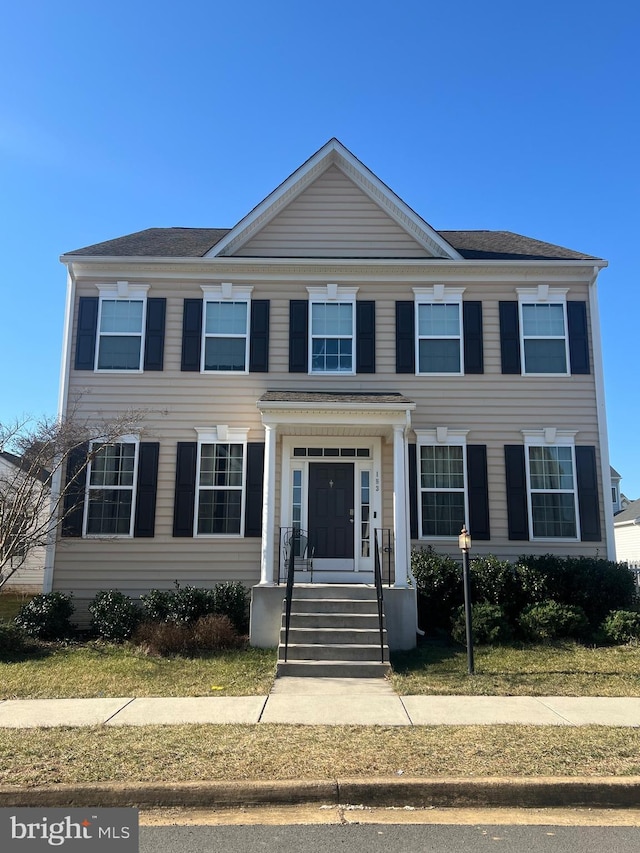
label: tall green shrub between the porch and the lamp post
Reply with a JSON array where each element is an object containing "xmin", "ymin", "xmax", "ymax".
[{"xmin": 411, "ymin": 545, "xmax": 462, "ymax": 630}]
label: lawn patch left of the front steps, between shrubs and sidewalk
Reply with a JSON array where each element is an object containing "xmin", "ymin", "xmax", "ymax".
[{"xmin": 0, "ymin": 643, "xmax": 276, "ymax": 699}]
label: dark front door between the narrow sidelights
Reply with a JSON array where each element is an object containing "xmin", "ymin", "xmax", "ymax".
[{"xmin": 309, "ymin": 462, "xmax": 354, "ymax": 560}]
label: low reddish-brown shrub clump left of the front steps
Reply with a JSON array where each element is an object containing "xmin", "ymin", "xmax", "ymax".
[{"xmin": 133, "ymin": 614, "xmax": 244, "ymax": 655}]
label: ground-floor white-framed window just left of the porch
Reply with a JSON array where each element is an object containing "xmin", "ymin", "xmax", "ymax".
[{"xmin": 195, "ymin": 426, "xmax": 249, "ymax": 536}]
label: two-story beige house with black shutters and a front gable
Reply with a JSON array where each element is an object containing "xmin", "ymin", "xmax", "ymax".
[{"xmin": 45, "ymin": 139, "xmax": 613, "ymax": 648}]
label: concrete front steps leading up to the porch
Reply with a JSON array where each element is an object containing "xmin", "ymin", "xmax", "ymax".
[{"xmin": 276, "ymin": 584, "xmax": 390, "ymax": 678}]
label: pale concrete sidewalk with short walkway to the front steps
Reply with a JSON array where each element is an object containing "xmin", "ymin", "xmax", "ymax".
[{"xmin": 0, "ymin": 678, "xmax": 640, "ymax": 728}]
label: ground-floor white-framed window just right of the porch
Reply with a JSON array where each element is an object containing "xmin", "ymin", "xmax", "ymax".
[{"xmin": 416, "ymin": 427, "xmax": 468, "ymax": 539}]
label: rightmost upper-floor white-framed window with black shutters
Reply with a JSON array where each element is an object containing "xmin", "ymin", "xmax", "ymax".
[{"xmin": 517, "ymin": 284, "xmax": 569, "ymax": 376}]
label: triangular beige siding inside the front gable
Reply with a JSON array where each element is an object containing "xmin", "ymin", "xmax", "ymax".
[{"xmin": 235, "ymin": 165, "xmax": 429, "ymax": 258}]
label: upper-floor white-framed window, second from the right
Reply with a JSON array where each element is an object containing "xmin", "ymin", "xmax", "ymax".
[{"xmin": 413, "ymin": 284, "xmax": 464, "ymax": 375}]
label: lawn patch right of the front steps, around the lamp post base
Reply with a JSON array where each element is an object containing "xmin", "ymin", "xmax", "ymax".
[{"xmin": 392, "ymin": 642, "xmax": 640, "ymax": 696}]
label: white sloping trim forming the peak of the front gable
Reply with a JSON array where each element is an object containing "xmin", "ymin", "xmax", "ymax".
[{"xmin": 204, "ymin": 139, "xmax": 462, "ymax": 260}]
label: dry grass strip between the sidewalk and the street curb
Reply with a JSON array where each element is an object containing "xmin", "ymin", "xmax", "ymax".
[{"xmin": 0, "ymin": 724, "xmax": 640, "ymax": 787}]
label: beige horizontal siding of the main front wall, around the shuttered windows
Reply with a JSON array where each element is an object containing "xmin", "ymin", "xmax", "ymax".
[{"xmin": 54, "ymin": 262, "xmax": 609, "ymax": 624}]
